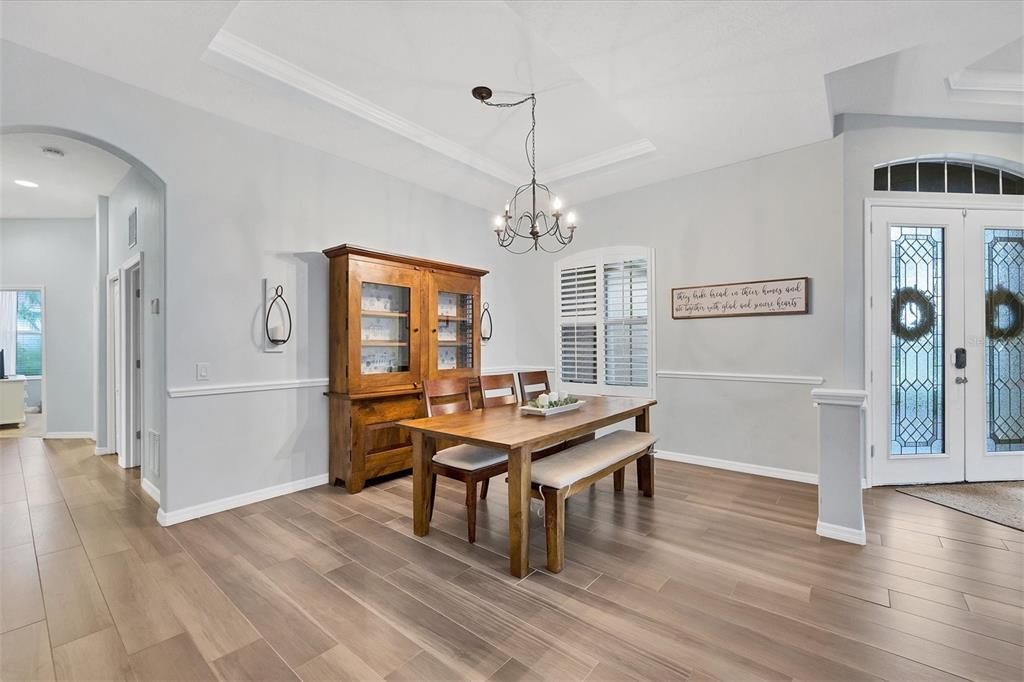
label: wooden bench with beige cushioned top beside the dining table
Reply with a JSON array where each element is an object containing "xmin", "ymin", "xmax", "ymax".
[{"xmin": 530, "ymin": 431, "xmax": 657, "ymax": 573}]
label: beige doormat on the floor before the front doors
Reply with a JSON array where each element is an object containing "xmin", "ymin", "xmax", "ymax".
[{"xmin": 896, "ymin": 480, "xmax": 1024, "ymax": 530}]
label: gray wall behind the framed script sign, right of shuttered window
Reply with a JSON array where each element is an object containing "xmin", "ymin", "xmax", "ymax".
[{"xmin": 569, "ymin": 139, "xmax": 843, "ymax": 473}]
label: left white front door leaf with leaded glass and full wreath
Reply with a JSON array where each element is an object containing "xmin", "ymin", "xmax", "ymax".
[{"xmin": 868, "ymin": 207, "xmax": 967, "ymax": 485}]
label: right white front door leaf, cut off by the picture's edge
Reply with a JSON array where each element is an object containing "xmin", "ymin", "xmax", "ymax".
[{"xmin": 963, "ymin": 209, "xmax": 1024, "ymax": 481}]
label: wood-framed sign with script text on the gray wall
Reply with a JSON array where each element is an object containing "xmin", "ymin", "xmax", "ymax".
[{"xmin": 672, "ymin": 278, "xmax": 811, "ymax": 319}]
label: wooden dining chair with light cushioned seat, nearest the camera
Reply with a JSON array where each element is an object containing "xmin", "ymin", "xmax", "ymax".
[{"xmin": 423, "ymin": 378, "xmax": 514, "ymax": 543}]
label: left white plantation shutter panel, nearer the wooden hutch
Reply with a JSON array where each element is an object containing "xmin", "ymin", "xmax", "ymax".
[{"xmin": 559, "ymin": 265, "xmax": 597, "ymax": 384}]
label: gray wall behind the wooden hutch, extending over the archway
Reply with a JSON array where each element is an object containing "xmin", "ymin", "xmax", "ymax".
[{"xmin": 0, "ymin": 42, "xmax": 551, "ymax": 512}]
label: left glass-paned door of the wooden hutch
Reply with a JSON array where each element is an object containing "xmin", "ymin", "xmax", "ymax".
[{"xmin": 348, "ymin": 261, "xmax": 422, "ymax": 391}]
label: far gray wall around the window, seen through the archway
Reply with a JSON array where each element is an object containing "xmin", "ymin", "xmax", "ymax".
[{"xmin": 0, "ymin": 219, "xmax": 96, "ymax": 433}]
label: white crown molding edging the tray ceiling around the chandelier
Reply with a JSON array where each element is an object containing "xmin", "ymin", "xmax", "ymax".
[{"xmin": 207, "ymin": 29, "xmax": 654, "ymax": 186}]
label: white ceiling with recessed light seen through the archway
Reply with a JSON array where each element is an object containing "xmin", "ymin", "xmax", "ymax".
[{"xmin": 0, "ymin": 133, "xmax": 130, "ymax": 218}]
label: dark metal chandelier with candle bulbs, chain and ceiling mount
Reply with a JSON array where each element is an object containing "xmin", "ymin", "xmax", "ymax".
[{"xmin": 473, "ymin": 85, "xmax": 577, "ymax": 254}]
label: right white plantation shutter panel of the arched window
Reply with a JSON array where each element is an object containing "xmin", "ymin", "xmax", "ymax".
[{"xmin": 604, "ymin": 259, "xmax": 650, "ymax": 387}]
